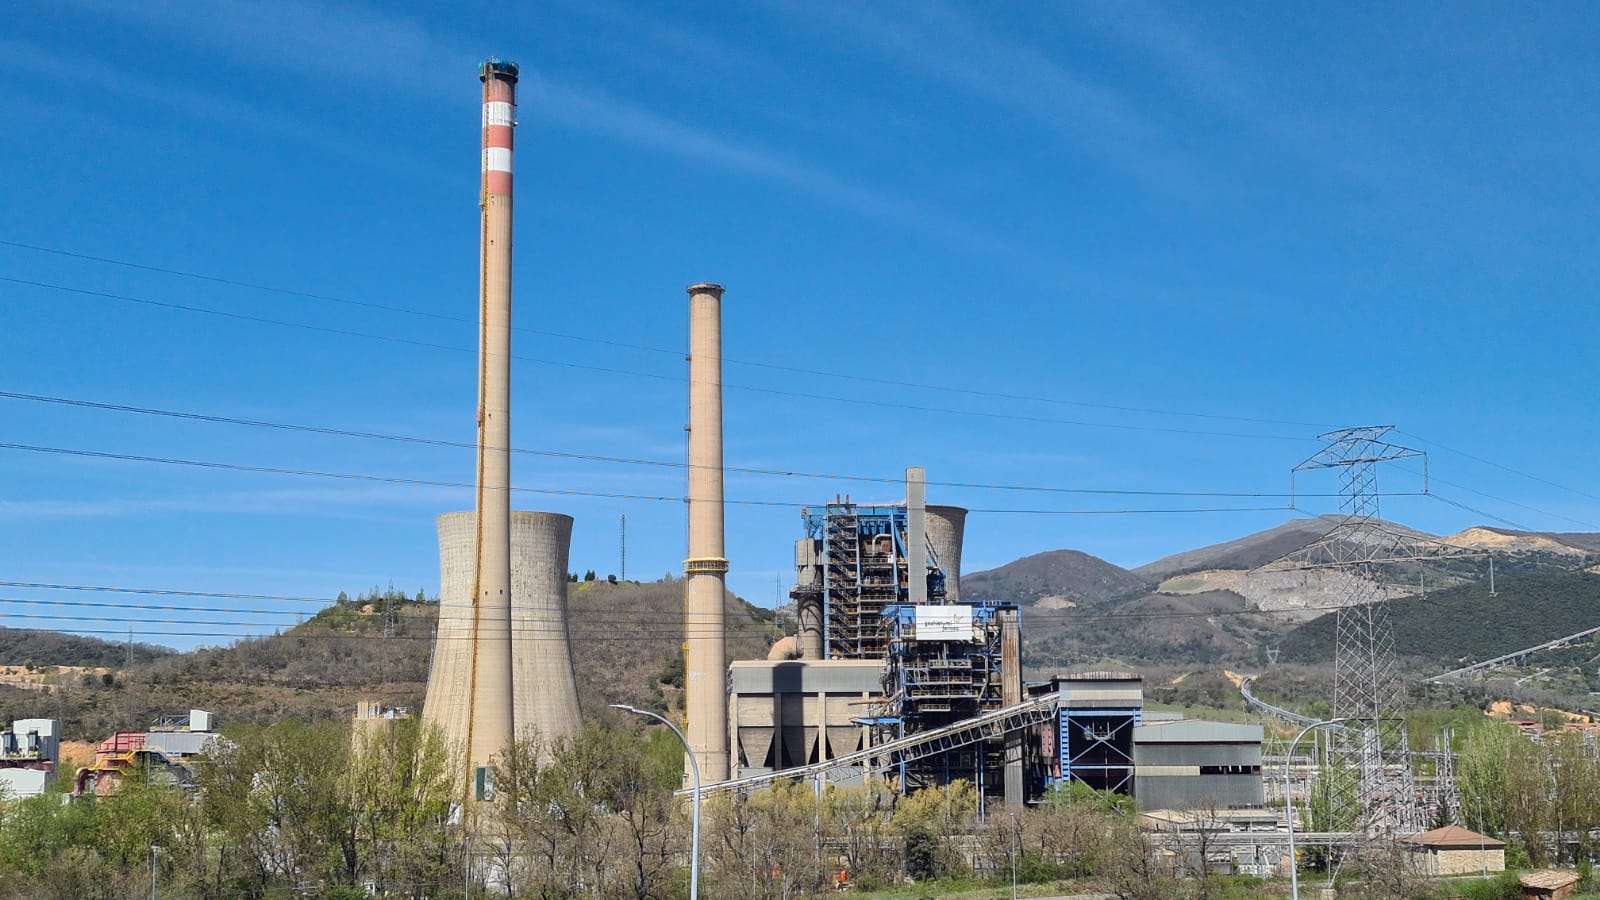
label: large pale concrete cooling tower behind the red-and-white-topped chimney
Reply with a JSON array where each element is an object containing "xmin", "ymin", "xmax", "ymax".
[{"xmin": 422, "ymin": 511, "xmax": 582, "ymax": 753}]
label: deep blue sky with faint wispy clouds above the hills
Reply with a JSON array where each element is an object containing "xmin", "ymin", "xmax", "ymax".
[{"xmin": 0, "ymin": 0, "xmax": 1600, "ymax": 645}]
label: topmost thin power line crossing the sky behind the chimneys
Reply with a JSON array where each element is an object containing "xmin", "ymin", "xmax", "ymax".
[{"xmin": 0, "ymin": 240, "xmax": 1328, "ymax": 429}]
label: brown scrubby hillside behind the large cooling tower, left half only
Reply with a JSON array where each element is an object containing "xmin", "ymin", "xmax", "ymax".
[{"xmin": 0, "ymin": 580, "xmax": 778, "ymax": 740}]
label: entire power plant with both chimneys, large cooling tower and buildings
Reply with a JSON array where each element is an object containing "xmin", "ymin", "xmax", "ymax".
[{"xmin": 422, "ymin": 58, "xmax": 1262, "ymax": 809}]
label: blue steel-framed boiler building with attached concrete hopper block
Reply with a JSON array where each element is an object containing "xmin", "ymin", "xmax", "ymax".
[{"xmin": 730, "ymin": 486, "xmax": 1026, "ymax": 806}]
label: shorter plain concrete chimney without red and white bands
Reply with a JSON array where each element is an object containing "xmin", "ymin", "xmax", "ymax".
[{"xmin": 683, "ymin": 283, "xmax": 730, "ymax": 785}]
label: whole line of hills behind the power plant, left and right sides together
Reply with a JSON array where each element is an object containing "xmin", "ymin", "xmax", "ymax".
[{"xmin": 0, "ymin": 517, "xmax": 1600, "ymax": 737}]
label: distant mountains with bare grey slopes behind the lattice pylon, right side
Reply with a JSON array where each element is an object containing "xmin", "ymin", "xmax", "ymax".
[{"xmin": 962, "ymin": 517, "xmax": 1600, "ymax": 668}]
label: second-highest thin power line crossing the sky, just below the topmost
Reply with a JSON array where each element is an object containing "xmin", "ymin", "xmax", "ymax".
[{"xmin": 0, "ymin": 275, "xmax": 1312, "ymax": 442}]
